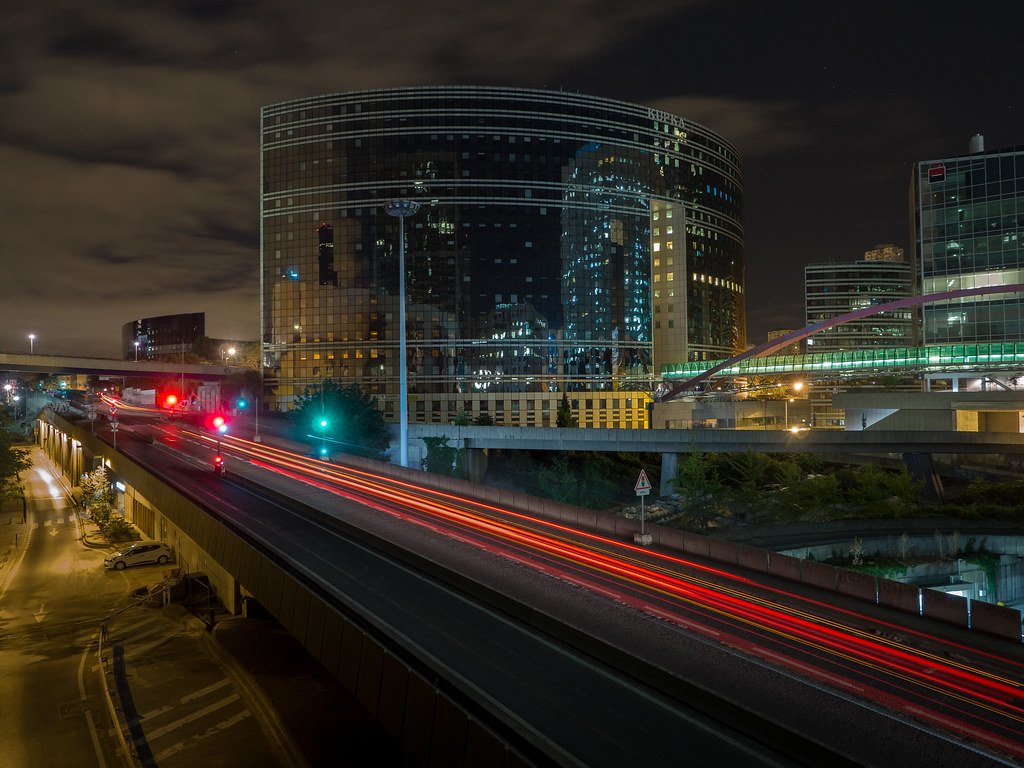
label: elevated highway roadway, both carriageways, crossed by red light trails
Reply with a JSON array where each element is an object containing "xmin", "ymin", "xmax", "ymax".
[{"xmin": 97, "ymin": 409, "xmax": 1024, "ymax": 767}]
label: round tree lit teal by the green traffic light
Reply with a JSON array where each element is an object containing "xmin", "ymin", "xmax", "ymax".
[{"xmin": 289, "ymin": 379, "xmax": 388, "ymax": 458}]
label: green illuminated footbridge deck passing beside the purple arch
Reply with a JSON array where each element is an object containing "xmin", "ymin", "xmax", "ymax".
[{"xmin": 662, "ymin": 342, "xmax": 1024, "ymax": 379}]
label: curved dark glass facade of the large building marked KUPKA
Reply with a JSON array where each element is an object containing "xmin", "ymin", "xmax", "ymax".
[{"xmin": 260, "ymin": 86, "xmax": 745, "ymax": 423}]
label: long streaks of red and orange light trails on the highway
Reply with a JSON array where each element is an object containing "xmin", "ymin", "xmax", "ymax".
[{"xmin": 167, "ymin": 431, "xmax": 1024, "ymax": 759}]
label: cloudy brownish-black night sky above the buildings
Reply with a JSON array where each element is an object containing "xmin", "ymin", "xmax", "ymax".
[{"xmin": 0, "ymin": 0, "xmax": 1024, "ymax": 357}]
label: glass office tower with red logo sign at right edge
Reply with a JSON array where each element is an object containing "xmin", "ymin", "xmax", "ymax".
[{"xmin": 910, "ymin": 136, "xmax": 1024, "ymax": 345}]
